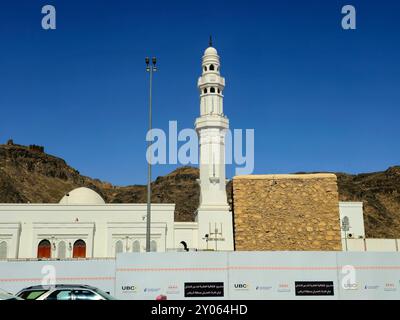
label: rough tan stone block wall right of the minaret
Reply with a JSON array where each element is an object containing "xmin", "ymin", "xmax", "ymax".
[{"xmin": 233, "ymin": 174, "xmax": 342, "ymax": 251}]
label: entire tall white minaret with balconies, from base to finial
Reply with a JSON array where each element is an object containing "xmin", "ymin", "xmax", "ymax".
[{"xmin": 195, "ymin": 38, "xmax": 233, "ymax": 250}]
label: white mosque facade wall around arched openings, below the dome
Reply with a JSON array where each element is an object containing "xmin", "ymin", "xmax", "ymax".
[{"xmin": 0, "ymin": 204, "xmax": 175, "ymax": 259}]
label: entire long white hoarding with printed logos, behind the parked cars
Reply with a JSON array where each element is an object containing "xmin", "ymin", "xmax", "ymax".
[{"xmin": 0, "ymin": 251, "xmax": 400, "ymax": 300}]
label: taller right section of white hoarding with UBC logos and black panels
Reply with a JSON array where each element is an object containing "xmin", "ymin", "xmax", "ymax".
[{"xmin": 115, "ymin": 251, "xmax": 400, "ymax": 300}]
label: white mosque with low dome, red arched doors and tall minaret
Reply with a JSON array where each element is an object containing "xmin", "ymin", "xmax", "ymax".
[{"xmin": 0, "ymin": 43, "xmax": 234, "ymax": 259}]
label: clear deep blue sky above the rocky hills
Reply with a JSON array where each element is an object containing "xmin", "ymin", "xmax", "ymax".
[{"xmin": 0, "ymin": 0, "xmax": 400, "ymax": 185}]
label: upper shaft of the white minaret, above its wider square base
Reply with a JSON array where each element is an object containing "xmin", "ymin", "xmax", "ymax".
[{"xmin": 195, "ymin": 42, "xmax": 229, "ymax": 206}]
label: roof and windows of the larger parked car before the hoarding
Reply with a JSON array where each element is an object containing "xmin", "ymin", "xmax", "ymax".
[{"xmin": 17, "ymin": 284, "xmax": 116, "ymax": 300}]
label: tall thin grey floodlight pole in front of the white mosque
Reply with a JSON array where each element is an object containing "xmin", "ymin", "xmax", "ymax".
[{"xmin": 145, "ymin": 57, "xmax": 157, "ymax": 252}]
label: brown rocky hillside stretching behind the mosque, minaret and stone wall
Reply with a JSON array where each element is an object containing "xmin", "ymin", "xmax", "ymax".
[{"xmin": 0, "ymin": 141, "xmax": 400, "ymax": 238}]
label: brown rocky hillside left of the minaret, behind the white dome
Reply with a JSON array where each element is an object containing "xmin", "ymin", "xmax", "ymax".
[{"xmin": 0, "ymin": 142, "xmax": 200, "ymax": 221}]
